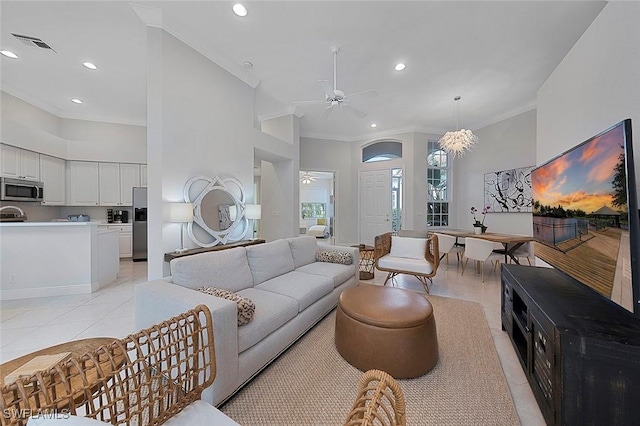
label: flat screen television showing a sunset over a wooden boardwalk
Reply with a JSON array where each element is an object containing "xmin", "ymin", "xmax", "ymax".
[{"xmin": 531, "ymin": 119, "xmax": 640, "ymax": 317}]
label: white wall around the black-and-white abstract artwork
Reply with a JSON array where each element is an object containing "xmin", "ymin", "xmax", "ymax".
[{"xmin": 451, "ymin": 106, "xmax": 536, "ymax": 235}]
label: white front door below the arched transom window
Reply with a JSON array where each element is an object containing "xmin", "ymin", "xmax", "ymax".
[{"xmin": 360, "ymin": 169, "xmax": 391, "ymax": 245}]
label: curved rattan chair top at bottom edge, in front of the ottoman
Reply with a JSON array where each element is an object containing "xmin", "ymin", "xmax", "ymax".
[{"xmin": 345, "ymin": 370, "xmax": 406, "ymax": 426}]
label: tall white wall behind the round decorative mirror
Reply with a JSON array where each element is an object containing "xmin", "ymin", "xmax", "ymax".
[{"xmin": 147, "ymin": 27, "xmax": 298, "ymax": 279}]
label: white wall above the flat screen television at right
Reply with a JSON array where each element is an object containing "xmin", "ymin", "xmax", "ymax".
[{"xmin": 536, "ymin": 2, "xmax": 640, "ymax": 203}]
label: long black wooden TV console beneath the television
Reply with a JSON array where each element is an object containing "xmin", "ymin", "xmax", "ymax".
[{"xmin": 502, "ymin": 265, "xmax": 640, "ymax": 425}]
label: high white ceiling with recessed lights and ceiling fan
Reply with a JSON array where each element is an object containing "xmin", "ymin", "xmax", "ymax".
[{"xmin": 0, "ymin": 1, "xmax": 606, "ymax": 140}]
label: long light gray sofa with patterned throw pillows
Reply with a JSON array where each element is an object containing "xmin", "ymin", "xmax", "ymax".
[{"xmin": 135, "ymin": 236, "xmax": 359, "ymax": 406}]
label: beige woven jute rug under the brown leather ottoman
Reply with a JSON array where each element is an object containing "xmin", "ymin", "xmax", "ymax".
[{"xmin": 221, "ymin": 295, "xmax": 520, "ymax": 426}]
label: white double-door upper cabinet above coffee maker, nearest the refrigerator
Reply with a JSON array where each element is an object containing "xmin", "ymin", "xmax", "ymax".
[{"xmin": 99, "ymin": 163, "xmax": 140, "ymax": 206}]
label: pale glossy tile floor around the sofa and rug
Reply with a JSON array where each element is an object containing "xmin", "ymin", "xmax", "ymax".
[{"xmin": 0, "ymin": 255, "xmax": 545, "ymax": 426}]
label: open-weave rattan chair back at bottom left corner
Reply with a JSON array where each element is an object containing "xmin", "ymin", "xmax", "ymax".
[{"xmin": 0, "ymin": 305, "xmax": 216, "ymax": 426}]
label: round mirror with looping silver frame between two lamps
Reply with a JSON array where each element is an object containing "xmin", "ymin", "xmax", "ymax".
[{"xmin": 184, "ymin": 176, "xmax": 249, "ymax": 247}]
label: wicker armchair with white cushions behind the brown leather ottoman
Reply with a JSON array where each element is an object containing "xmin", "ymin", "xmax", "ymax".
[{"xmin": 374, "ymin": 232, "xmax": 440, "ymax": 293}]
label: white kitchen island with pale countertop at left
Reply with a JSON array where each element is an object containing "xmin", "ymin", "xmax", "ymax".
[{"xmin": 0, "ymin": 222, "xmax": 119, "ymax": 300}]
